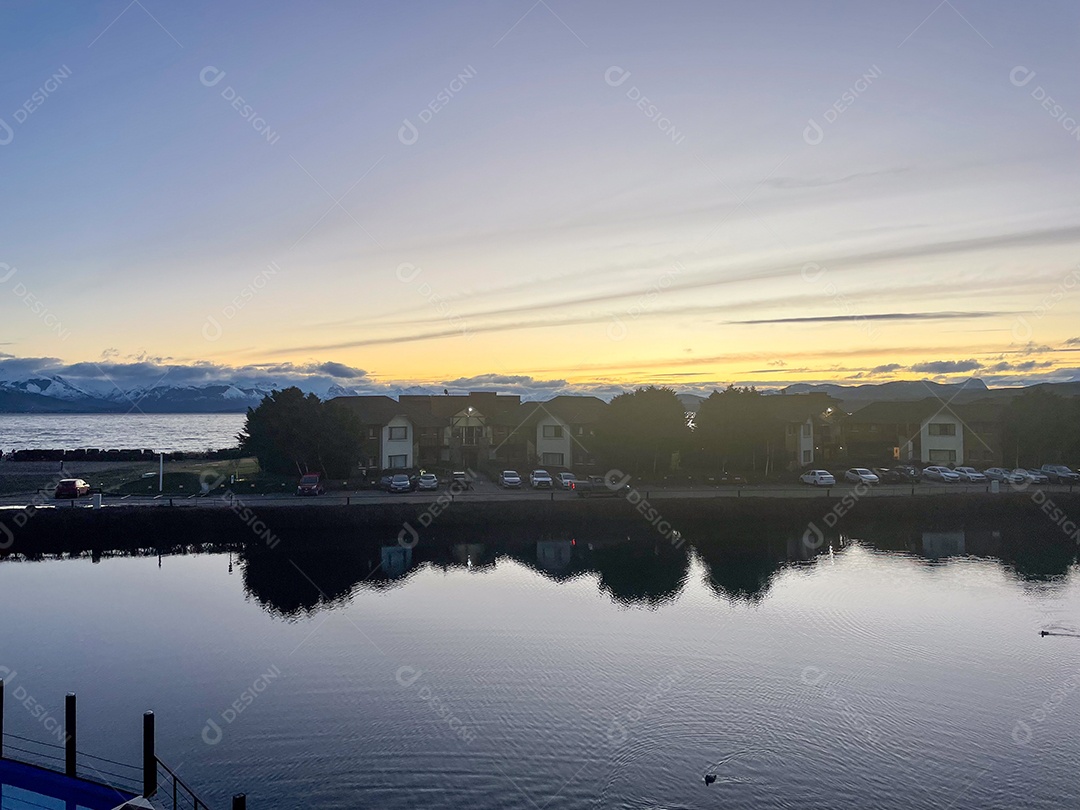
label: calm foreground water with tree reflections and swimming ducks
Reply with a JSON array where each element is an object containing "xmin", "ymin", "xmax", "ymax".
[{"xmin": 0, "ymin": 532, "xmax": 1080, "ymax": 810}]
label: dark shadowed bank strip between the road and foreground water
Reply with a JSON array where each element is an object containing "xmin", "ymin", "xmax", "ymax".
[{"xmin": 0, "ymin": 489, "xmax": 1080, "ymax": 555}]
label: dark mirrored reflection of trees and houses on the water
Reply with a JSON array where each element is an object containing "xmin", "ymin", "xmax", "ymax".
[{"xmin": 239, "ymin": 516, "xmax": 1076, "ymax": 618}]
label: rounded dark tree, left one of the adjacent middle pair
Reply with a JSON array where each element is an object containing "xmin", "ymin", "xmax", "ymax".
[{"xmin": 596, "ymin": 386, "xmax": 689, "ymax": 474}]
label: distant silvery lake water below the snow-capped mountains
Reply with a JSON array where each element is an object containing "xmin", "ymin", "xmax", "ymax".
[{"xmin": 0, "ymin": 414, "xmax": 244, "ymax": 453}]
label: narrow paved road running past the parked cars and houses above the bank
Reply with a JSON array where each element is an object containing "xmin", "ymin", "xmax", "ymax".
[{"xmin": 0, "ymin": 481, "xmax": 1067, "ymax": 510}]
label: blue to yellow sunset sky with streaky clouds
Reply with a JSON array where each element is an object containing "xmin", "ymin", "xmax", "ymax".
[{"xmin": 0, "ymin": 0, "xmax": 1080, "ymax": 393}]
